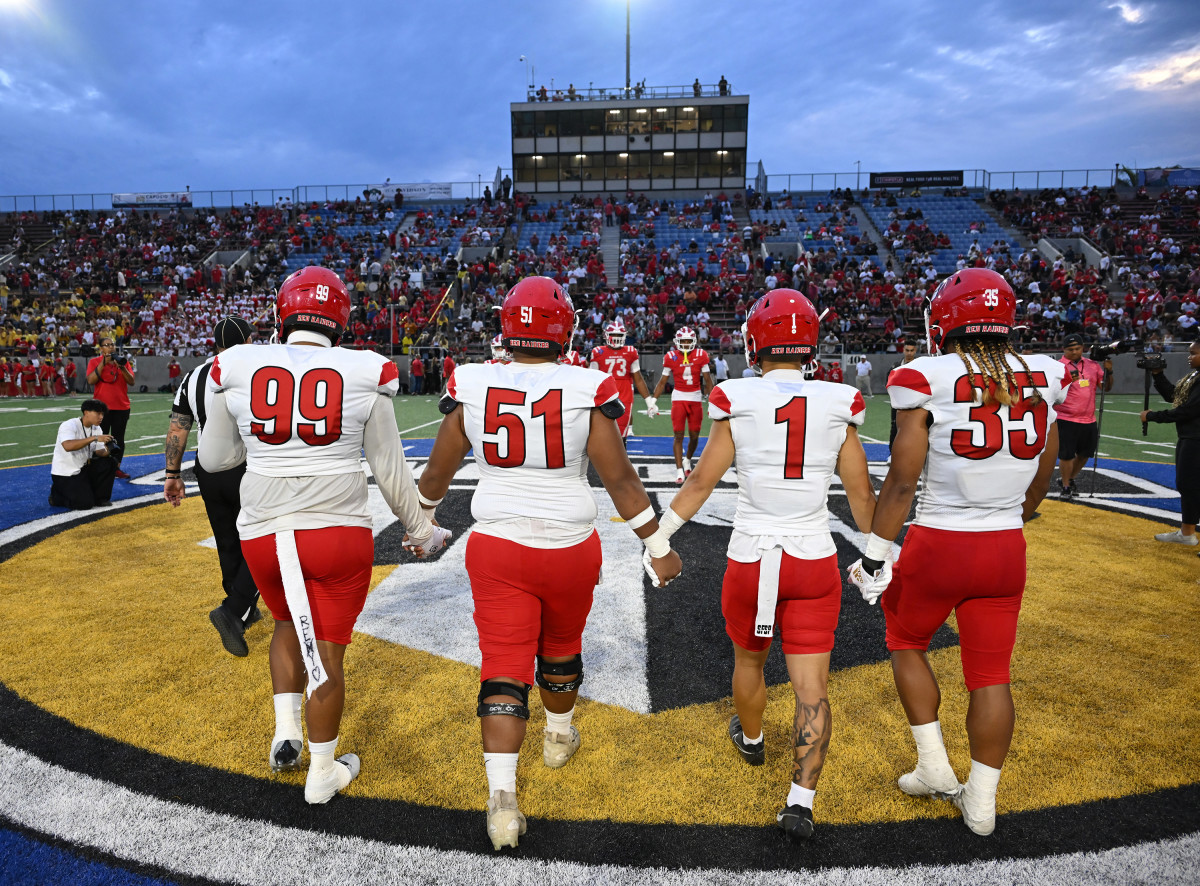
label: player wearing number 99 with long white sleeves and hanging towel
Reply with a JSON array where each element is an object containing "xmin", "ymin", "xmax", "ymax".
[{"xmin": 197, "ymin": 267, "xmax": 449, "ymax": 803}]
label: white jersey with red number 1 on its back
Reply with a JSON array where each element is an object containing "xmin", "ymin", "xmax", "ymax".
[{"xmin": 708, "ymin": 370, "xmax": 866, "ymax": 545}]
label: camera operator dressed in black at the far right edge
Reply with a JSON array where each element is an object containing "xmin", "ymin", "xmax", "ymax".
[{"xmin": 1141, "ymin": 342, "xmax": 1200, "ymax": 545}]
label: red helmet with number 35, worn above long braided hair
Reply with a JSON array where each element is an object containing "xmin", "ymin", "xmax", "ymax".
[{"xmin": 925, "ymin": 268, "xmax": 1016, "ymax": 354}]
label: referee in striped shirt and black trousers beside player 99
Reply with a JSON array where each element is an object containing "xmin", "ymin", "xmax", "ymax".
[{"xmin": 162, "ymin": 317, "xmax": 263, "ymax": 657}]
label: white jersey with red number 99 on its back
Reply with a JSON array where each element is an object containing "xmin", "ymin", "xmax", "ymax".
[{"xmin": 209, "ymin": 345, "xmax": 400, "ymax": 477}]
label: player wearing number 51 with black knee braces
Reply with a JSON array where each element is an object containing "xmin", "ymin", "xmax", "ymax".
[{"xmin": 420, "ymin": 277, "xmax": 680, "ymax": 850}]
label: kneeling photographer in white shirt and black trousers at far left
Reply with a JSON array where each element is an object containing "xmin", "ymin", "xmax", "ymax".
[{"xmin": 49, "ymin": 400, "xmax": 116, "ymax": 510}]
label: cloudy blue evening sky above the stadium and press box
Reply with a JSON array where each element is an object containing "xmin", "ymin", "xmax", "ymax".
[{"xmin": 0, "ymin": 0, "xmax": 1200, "ymax": 194}]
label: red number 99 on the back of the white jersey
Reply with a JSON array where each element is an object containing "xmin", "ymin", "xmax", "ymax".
[{"xmin": 250, "ymin": 366, "xmax": 342, "ymax": 447}]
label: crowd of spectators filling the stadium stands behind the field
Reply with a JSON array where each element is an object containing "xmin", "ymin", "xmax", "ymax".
[{"xmin": 0, "ymin": 182, "xmax": 1200, "ymax": 379}]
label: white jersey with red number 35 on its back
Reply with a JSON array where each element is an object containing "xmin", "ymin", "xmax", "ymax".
[{"xmin": 888, "ymin": 354, "xmax": 1067, "ymax": 532}]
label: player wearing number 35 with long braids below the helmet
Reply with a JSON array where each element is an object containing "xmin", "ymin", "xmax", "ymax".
[{"xmin": 848, "ymin": 268, "xmax": 1070, "ymax": 836}]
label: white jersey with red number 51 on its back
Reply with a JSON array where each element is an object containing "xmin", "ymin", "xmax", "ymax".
[{"xmin": 445, "ymin": 363, "xmax": 620, "ymax": 547}]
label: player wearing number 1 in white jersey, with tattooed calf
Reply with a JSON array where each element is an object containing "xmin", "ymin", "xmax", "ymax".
[{"xmin": 661, "ymin": 289, "xmax": 875, "ymax": 840}]
